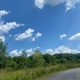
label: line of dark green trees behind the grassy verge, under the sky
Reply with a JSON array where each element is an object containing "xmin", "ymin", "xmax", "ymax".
[{"xmin": 0, "ymin": 39, "xmax": 80, "ymax": 70}]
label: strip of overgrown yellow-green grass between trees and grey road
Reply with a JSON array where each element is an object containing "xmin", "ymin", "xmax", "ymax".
[{"xmin": 0, "ymin": 63, "xmax": 80, "ymax": 80}]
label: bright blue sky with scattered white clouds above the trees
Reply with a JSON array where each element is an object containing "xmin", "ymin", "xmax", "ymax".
[{"xmin": 0, "ymin": 0, "xmax": 80, "ymax": 56}]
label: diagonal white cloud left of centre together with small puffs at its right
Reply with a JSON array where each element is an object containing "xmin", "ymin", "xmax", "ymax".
[{"xmin": 14, "ymin": 28, "xmax": 42, "ymax": 41}]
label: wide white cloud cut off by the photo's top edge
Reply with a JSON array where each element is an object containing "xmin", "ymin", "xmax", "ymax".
[{"xmin": 35, "ymin": 0, "xmax": 80, "ymax": 11}]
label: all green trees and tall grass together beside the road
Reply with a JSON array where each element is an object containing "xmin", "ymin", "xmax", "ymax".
[{"xmin": 0, "ymin": 40, "xmax": 80, "ymax": 80}]
